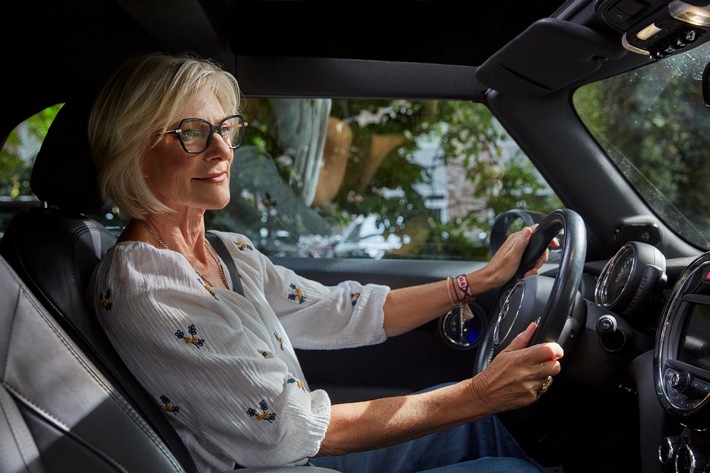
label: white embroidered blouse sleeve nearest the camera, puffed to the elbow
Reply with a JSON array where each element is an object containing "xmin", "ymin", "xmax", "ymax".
[{"xmin": 89, "ymin": 243, "xmax": 330, "ymax": 468}]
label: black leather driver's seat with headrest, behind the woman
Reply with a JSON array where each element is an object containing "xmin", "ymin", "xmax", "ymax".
[{"xmin": 0, "ymin": 104, "xmax": 203, "ymax": 472}]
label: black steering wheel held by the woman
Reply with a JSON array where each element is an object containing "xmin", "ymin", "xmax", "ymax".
[{"xmin": 474, "ymin": 209, "xmax": 587, "ymax": 374}]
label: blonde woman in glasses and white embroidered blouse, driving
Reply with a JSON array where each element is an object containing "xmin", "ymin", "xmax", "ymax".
[{"xmin": 89, "ymin": 51, "xmax": 563, "ymax": 472}]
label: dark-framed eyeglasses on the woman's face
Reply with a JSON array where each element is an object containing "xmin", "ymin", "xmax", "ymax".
[{"xmin": 158, "ymin": 115, "xmax": 249, "ymax": 154}]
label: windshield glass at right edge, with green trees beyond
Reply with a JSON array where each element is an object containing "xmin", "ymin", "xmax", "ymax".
[{"xmin": 574, "ymin": 39, "xmax": 710, "ymax": 250}]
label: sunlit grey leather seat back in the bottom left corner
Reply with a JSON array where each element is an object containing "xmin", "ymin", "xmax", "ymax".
[{"xmin": 0, "ymin": 258, "xmax": 185, "ymax": 473}]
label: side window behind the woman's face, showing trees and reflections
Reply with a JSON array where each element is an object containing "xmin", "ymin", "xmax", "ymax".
[{"xmin": 208, "ymin": 98, "xmax": 561, "ymax": 260}]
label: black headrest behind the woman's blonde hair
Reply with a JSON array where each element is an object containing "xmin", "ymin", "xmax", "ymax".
[{"xmin": 30, "ymin": 102, "xmax": 104, "ymax": 214}]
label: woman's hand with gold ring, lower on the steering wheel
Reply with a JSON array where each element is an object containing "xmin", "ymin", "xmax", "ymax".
[{"xmin": 470, "ymin": 322, "xmax": 564, "ymax": 415}]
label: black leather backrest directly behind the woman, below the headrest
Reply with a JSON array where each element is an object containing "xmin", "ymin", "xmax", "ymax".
[{"xmin": 0, "ymin": 208, "xmax": 197, "ymax": 472}]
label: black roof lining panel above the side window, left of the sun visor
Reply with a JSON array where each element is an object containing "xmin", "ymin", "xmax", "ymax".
[{"xmin": 228, "ymin": 0, "xmax": 564, "ymax": 66}]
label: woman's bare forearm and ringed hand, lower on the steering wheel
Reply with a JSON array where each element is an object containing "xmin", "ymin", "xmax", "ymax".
[{"xmin": 318, "ymin": 323, "xmax": 563, "ymax": 456}]
